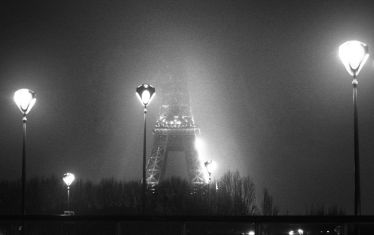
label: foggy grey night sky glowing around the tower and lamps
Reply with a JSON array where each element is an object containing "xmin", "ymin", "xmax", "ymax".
[{"xmin": 0, "ymin": 0, "xmax": 374, "ymax": 214}]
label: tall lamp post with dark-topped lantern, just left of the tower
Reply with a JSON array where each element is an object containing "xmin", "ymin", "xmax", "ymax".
[{"xmin": 136, "ymin": 84, "xmax": 156, "ymax": 214}]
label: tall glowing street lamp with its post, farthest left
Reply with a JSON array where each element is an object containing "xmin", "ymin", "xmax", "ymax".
[{"xmin": 13, "ymin": 88, "xmax": 36, "ymax": 215}]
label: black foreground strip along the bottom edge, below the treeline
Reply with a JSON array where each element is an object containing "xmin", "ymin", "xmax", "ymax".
[{"xmin": 0, "ymin": 215, "xmax": 374, "ymax": 235}]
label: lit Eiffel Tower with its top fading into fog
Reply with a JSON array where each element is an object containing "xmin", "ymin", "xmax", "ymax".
[{"xmin": 146, "ymin": 65, "xmax": 205, "ymax": 187}]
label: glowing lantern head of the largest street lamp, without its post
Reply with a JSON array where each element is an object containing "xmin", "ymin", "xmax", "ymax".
[{"xmin": 339, "ymin": 41, "xmax": 369, "ymax": 78}]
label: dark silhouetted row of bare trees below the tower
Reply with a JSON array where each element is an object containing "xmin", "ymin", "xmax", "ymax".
[{"xmin": 0, "ymin": 172, "xmax": 277, "ymax": 215}]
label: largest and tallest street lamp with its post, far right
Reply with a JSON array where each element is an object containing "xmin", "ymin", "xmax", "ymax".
[{"xmin": 339, "ymin": 41, "xmax": 369, "ymax": 215}]
